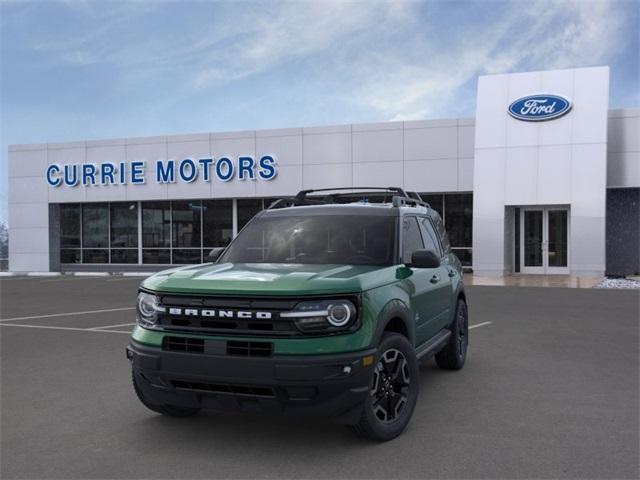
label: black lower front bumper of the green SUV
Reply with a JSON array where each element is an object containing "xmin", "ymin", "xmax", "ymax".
[{"xmin": 127, "ymin": 340, "xmax": 376, "ymax": 423}]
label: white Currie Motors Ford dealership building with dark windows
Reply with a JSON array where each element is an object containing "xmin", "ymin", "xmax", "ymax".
[{"xmin": 9, "ymin": 67, "xmax": 640, "ymax": 276}]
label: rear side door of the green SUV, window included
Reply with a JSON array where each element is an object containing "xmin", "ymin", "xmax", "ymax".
[{"xmin": 418, "ymin": 217, "xmax": 455, "ymax": 336}]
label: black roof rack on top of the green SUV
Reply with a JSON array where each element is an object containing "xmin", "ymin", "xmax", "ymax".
[{"xmin": 268, "ymin": 187, "xmax": 431, "ymax": 210}]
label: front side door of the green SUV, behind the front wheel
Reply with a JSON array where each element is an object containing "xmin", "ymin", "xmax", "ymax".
[{"xmin": 402, "ymin": 216, "xmax": 442, "ymax": 345}]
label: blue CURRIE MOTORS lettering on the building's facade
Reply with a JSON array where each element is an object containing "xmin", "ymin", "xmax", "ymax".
[{"xmin": 45, "ymin": 155, "xmax": 278, "ymax": 187}]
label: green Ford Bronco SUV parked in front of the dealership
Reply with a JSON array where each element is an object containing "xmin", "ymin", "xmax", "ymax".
[{"xmin": 127, "ymin": 188, "xmax": 469, "ymax": 440}]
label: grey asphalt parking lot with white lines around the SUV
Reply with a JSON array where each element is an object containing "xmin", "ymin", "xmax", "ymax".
[{"xmin": 0, "ymin": 277, "xmax": 640, "ymax": 479}]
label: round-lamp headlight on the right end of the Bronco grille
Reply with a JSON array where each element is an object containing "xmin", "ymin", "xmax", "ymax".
[{"xmin": 280, "ymin": 300, "xmax": 357, "ymax": 333}]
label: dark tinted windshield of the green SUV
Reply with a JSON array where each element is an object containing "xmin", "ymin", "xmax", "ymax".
[{"xmin": 220, "ymin": 215, "xmax": 396, "ymax": 266}]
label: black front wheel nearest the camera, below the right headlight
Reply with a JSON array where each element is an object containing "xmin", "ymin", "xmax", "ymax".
[{"xmin": 353, "ymin": 333, "xmax": 420, "ymax": 441}]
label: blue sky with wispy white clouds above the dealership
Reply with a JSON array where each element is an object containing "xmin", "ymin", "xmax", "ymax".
[{"xmin": 0, "ymin": 0, "xmax": 640, "ymax": 220}]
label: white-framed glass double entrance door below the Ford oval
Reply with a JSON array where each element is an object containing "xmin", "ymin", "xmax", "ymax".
[{"xmin": 519, "ymin": 207, "xmax": 569, "ymax": 274}]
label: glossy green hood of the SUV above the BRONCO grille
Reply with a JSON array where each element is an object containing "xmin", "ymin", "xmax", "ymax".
[{"xmin": 141, "ymin": 263, "xmax": 397, "ymax": 295}]
